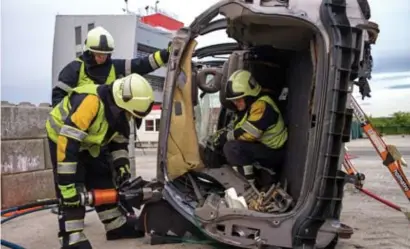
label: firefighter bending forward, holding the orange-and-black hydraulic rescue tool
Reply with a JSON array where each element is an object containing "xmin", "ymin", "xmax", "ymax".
[{"xmin": 46, "ymin": 74, "xmax": 154, "ymax": 249}]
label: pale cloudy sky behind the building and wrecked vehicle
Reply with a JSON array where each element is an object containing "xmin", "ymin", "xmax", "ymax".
[{"xmin": 1, "ymin": 0, "xmax": 410, "ymax": 116}]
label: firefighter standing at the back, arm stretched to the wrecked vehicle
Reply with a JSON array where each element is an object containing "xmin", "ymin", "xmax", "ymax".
[{"xmin": 52, "ymin": 27, "xmax": 169, "ymax": 107}]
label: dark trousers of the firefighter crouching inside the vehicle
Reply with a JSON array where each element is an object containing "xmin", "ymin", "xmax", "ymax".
[{"xmin": 223, "ymin": 140, "xmax": 284, "ymax": 185}]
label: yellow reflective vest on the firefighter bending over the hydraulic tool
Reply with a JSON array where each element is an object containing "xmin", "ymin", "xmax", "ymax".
[{"xmin": 46, "ymin": 84, "xmax": 122, "ymax": 157}]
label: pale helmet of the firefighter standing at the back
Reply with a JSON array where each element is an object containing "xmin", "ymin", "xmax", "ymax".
[{"xmin": 84, "ymin": 27, "xmax": 114, "ymax": 54}]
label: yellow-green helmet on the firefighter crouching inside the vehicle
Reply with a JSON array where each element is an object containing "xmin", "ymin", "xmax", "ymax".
[{"xmin": 226, "ymin": 69, "xmax": 262, "ymax": 100}]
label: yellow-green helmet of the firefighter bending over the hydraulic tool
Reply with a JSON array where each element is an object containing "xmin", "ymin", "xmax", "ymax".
[{"xmin": 112, "ymin": 73, "xmax": 154, "ymax": 118}]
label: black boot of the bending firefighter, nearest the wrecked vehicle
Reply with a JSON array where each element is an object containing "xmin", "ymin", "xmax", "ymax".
[{"xmin": 106, "ymin": 216, "xmax": 144, "ymax": 240}]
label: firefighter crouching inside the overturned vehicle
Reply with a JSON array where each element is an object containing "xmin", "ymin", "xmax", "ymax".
[{"xmin": 214, "ymin": 70, "xmax": 288, "ymax": 183}]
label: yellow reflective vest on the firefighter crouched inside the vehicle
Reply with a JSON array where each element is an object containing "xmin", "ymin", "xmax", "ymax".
[{"xmin": 234, "ymin": 95, "xmax": 288, "ymax": 149}]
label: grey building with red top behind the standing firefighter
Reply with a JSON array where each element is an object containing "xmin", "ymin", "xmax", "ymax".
[{"xmin": 52, "ymin": 13, "xmax": 184, "ymax": 146}]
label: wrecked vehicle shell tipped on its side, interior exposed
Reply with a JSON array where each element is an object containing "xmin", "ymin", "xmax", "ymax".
[{"xmin": 157, "ymin": 0, "xmax": 378, "ymax": 248}]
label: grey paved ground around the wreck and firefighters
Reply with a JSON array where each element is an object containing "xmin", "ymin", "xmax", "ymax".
[{"xmin": 1, "ymin": 136, "xmax": 410, "ymax": 249}]
